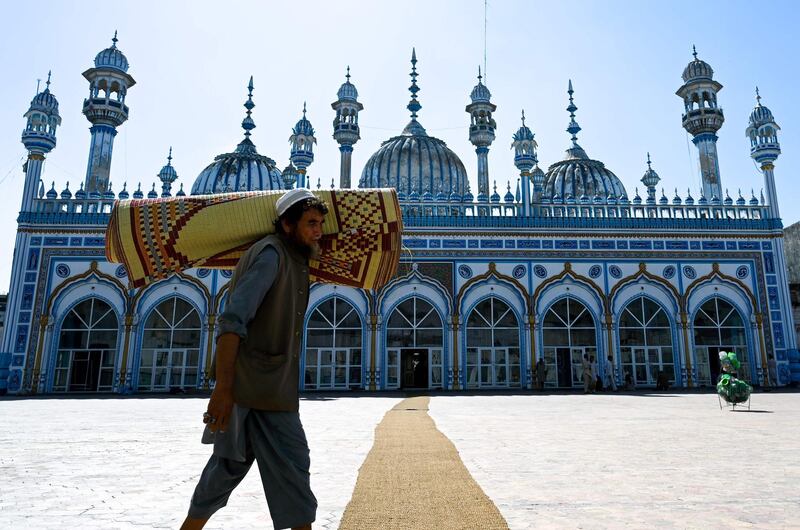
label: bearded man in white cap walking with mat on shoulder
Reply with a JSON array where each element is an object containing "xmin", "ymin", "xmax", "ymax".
[{"xmin": 181, "ymin": 188, "xmax": 328, "ymax": 530}]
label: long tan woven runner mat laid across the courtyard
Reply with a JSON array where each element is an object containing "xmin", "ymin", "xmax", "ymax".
[{"xmin": 339, "ymin": 397, "xmax": 508, "ymax": 530}]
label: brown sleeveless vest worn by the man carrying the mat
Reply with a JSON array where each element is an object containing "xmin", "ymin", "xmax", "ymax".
[{"xmin": 228, "ymin": 235, "xmax": 309, "ymax": 412}]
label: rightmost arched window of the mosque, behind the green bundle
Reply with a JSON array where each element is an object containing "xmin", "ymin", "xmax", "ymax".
[{"xmin": 693, "ymin": 296, "xmax": 750, "ymax": 385}]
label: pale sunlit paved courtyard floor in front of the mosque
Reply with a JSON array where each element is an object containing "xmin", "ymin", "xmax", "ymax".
[{"xmin": 0, "ymin": 393, "xmax": 800, "ymax": 530}]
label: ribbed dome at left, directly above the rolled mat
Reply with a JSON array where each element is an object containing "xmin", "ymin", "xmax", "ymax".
[{"xmin": 192, "ymin": 139, "xmax": 283, "ymax": 195}]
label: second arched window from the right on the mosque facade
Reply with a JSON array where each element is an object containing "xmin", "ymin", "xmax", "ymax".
[{"xmin": 619, "ymin": 296, "xmax": 675, "ymax": 386}]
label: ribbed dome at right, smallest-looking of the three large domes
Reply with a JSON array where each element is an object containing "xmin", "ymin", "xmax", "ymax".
[{"xmin": 544, "ymin": 147, "xmax": 627, "ymax": 199}]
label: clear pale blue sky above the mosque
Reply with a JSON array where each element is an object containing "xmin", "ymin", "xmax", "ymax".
[{"xmin": 0, "ymin": 0, "xmax": 800, "ymax": 292}]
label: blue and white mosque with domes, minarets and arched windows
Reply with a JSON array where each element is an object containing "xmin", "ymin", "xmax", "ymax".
[{"xmin": 0, "ymin": 35, "xmax": 800, "ymax": 395}]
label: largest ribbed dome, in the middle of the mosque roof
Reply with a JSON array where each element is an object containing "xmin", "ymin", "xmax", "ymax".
[{"xmin": 358, "ymin": 120, "xmax": 469, "ymax": 196}]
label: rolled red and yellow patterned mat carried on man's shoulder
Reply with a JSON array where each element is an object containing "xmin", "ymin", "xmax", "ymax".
[{"xmin": 105, "ymin": 188, "xmax": 403, "ymax": 289}]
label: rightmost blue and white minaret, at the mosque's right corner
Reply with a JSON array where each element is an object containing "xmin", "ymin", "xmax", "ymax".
[{"xmin": 745, "ymin": 87, "xmax": 781, "ymax": 219}]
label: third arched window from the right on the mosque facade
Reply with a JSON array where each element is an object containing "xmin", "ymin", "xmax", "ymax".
[{"xmin": 542, "ymin": 298, "xmax": 599, "ymax": 387}]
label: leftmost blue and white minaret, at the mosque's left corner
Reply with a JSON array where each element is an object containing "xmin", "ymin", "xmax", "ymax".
[{"xmin": 20, "ymin": 72, "xmax": 61, "ymax": 212}]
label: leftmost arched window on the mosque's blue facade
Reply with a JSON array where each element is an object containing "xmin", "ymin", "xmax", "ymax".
[{"xmin": 53, "ymin": 298, "xmax": 119, "ymax": 392}]
